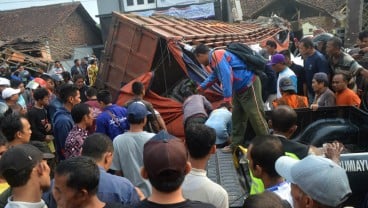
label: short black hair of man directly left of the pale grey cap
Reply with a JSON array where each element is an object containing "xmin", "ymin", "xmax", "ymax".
[{"xmin": 250, "ymin": 135, "xmax": 285, "ymax": 177}]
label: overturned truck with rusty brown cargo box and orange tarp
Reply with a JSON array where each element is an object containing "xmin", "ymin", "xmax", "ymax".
[{"xmin": 97, "ymin": 13, "xmax": 289, "ymax": 137}]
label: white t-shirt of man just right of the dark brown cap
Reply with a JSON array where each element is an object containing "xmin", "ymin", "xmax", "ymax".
[{"xmin": 182, "ymin": 168, "xmax": 229, "ymax": 208}]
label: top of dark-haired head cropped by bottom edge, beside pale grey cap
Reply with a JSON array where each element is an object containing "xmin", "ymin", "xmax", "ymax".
[{"xmin": 243, "ymin": 191, "xmax": 291, "ymax": 208}]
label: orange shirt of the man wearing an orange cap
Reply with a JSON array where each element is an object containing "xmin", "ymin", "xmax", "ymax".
[{"xmin": 272, "ymin": 94, "xmax": 308, "ymax": 108}]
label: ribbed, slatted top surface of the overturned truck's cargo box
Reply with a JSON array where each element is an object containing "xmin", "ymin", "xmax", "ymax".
[{"xmin": 121, "ymin": 14, "xmax": 282, "ymax": 46}]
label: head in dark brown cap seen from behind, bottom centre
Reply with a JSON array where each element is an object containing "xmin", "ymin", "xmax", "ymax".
[{"xmin": 141, "ymin": 131, "xmax": 191, "ymax": 193}]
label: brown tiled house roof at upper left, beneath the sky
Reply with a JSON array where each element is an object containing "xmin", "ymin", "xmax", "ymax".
[{"xmin": 0, "ymin": 2, "xmax": 93, "ymax": 42}]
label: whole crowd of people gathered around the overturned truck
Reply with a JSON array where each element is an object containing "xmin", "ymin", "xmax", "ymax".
[{"xmin": 0, "ymin": 32, "xmax": 368, "ymax": 208}]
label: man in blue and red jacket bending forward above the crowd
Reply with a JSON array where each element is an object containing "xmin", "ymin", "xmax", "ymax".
[{"xmin": 193, "ymin": 44, "xmax": 268, "ymax": 152}]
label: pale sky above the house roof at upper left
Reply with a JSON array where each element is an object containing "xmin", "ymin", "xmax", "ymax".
[{"xmin": 0, "ymin": 0, "xmax": 99, "ymax": 23}]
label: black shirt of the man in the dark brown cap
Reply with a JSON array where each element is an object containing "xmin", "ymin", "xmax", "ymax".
[{"xmin": 125, "ymin": 199, "xmax": 215, "ymax": 208}]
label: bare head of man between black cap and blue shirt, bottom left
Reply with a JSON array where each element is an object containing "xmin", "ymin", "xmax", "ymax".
[{"xmin": 52, "ymin": 156, "xmax": 100, "ymax": 208}]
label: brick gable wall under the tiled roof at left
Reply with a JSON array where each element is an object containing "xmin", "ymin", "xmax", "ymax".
[{"xmin": 49, "ymin": 10, "xmax": 102, "ymax": 60}]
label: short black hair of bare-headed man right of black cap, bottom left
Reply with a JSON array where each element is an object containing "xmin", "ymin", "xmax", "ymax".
[{"xmin": 55, "ymin": 156, "xmax": 100, "ymax": 195}]
